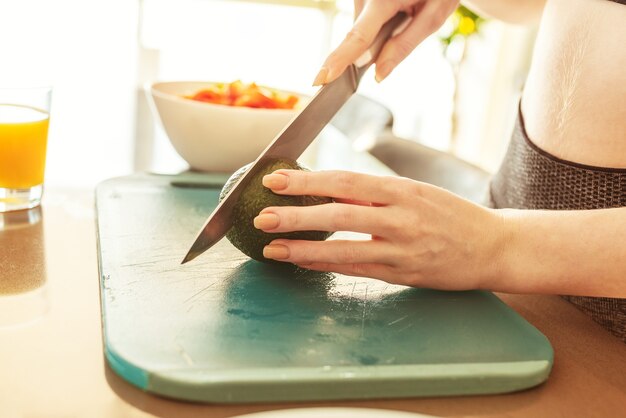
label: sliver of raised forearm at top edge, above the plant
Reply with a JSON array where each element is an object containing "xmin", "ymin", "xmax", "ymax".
[{"xmin": 462, "ymin": 0, "xmax": 546, "ymax": 24}]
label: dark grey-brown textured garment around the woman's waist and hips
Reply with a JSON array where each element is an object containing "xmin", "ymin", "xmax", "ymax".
[{"xmin": 490, "ymin": 107, "xmax": 626, "ymax": 342}]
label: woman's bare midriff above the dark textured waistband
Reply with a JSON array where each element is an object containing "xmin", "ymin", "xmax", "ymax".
[{"xmin": 522, "ymin": 0, "xmax": 626, "ymax": 168}]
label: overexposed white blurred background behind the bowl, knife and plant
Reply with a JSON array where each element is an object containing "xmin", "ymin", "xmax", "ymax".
[{"xmin": 0, "ymin": 0, "xmax": 535, "ymax": 187}]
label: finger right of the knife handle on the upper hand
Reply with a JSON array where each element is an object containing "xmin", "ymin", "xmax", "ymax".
[{"xmin": 376, "ymin": 0, "xmax": 458, "ymax": 82}]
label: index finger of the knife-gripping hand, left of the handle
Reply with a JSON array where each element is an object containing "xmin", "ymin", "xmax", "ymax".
[{"xmin": 313, "ymin": 1, "xmax": 397, "ymax": 85}]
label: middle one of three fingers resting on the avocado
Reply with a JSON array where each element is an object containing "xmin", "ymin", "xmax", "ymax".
[{"xmin": 254, "ymin": 203, "xmax": 395, "ymax": 237}]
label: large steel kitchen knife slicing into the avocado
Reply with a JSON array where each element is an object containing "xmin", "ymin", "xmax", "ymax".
[{"xmin": 181, "ymin": 13, "xmax": 406, "ymax": 264}]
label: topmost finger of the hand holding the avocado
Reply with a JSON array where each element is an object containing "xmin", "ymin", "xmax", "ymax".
[{"xmin": 263, "ymin": 170, "xmax": 406, "ymax": 204}]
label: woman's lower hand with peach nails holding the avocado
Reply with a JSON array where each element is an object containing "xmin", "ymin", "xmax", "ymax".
[{"xmin": 254, "ymin": 170, "xmax": 506, "ymax": 290}]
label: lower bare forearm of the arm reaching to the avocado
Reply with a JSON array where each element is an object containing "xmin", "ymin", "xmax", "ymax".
[{"xmin": 493, "ymin": 208, "xmax": 626, "ymax": 298}]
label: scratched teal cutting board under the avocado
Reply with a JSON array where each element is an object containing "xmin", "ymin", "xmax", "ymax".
[{"xmin": 96, "ymin": 174, "xmax": 553, "ymax": 402}]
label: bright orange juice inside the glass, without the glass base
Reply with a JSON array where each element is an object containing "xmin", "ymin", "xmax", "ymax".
[{"xmin": 0, "ymin": 104, "xmax": 49, "ymax": 189}]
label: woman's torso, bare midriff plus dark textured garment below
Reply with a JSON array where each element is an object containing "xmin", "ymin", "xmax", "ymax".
[{"xmin": 490, "ymin": 0, "xmax": 626, "ymax": 343}]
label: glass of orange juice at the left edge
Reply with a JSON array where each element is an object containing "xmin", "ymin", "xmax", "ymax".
[{"xmin": 0, "ymin": 87, "xmax": 52, "ymax": 212}]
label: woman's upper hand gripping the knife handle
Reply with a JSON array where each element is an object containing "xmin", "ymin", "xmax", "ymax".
[{"xmin": 313, "ymin": 0, "xmax": 459, "ymax": 86}]
